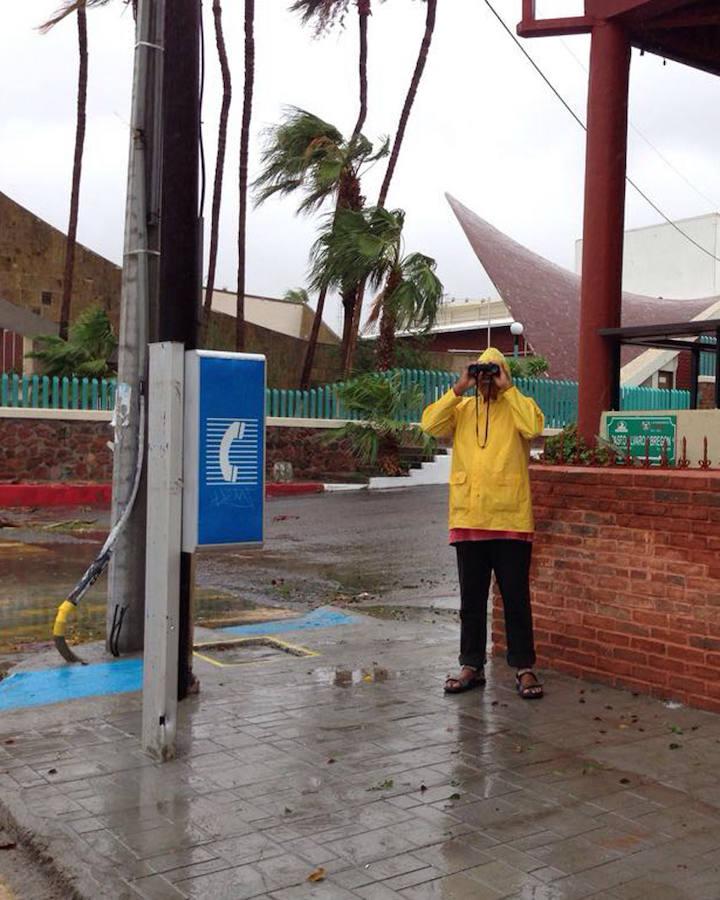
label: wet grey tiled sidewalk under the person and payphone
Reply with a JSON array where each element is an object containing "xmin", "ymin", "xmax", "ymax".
[{"xmin": 0, "ymin": 619, "xmax": 720, "ymax": 900}]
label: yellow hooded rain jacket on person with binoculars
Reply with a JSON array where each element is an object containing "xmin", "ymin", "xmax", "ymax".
[{"xmin": 421, "ymin": 347, "xmax": 545, "ymax": 532}]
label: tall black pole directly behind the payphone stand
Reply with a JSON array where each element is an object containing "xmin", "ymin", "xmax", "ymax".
[{"xmin": 156, "ymin": 0, "xmax": 202, "ymax": 700}]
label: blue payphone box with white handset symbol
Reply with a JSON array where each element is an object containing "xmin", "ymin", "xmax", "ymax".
[{"xmin": 183, "ymin": 350, "xmax": 265, "ymax": 553}]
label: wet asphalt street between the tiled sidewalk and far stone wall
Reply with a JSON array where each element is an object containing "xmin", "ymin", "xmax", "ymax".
[{"xmin": 0, "ymin": 486, "xmax": 456, "ymax": 654}]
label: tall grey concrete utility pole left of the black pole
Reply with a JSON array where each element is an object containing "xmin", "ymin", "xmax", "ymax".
[{"xmin": 107, "ymin": 0, "xmax": 165, "ymax": 653}]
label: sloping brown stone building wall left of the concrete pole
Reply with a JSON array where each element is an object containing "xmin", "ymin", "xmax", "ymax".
[{"xmin": 0, "ymin": 193, "xmax": 120, "ymax": 328}]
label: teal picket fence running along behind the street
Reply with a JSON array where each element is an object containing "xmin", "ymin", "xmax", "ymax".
[{"xmin": 0, "ymin": 366, "xmax": 692, "ymax": 428}]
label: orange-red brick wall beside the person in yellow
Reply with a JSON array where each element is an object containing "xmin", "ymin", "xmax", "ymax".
[{"xmin": 493, "ymin": 466, "xmax": 720, "ymax": 712}]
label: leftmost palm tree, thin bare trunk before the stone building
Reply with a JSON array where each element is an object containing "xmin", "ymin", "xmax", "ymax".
[{"xmin": 40, "ymin": 0, "xmax": 136, "ymax": 340}]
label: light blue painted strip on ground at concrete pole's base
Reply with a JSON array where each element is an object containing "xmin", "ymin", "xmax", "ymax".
[{"xmin": 0, "ymin": 658, "xmax": 143, "ymax": 711}]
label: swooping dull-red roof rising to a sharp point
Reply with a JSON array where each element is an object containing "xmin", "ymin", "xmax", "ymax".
[{"xmin": 446, "ymin": 194, "xmax": 720, "ymax": 379}]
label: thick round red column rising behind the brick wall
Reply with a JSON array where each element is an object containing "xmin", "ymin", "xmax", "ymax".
[{"xmin": 578, "ymin": 22, "xmax": 630, "ymax": 442}]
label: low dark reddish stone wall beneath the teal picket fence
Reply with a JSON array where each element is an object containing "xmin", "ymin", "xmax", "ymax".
[{"xmin": 0, "ymin": 418, "xmax": 357, "ymax": 482}]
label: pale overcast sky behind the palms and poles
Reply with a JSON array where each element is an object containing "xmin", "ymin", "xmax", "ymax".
[{"xmin": 0, "ymin": 0, "xmax": 720, "ymax": 327}]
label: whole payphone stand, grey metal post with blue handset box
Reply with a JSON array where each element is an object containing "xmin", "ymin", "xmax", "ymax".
[{"xmin": 142, "ymin": 342, "xmax": 265, "ymax": 760}]
